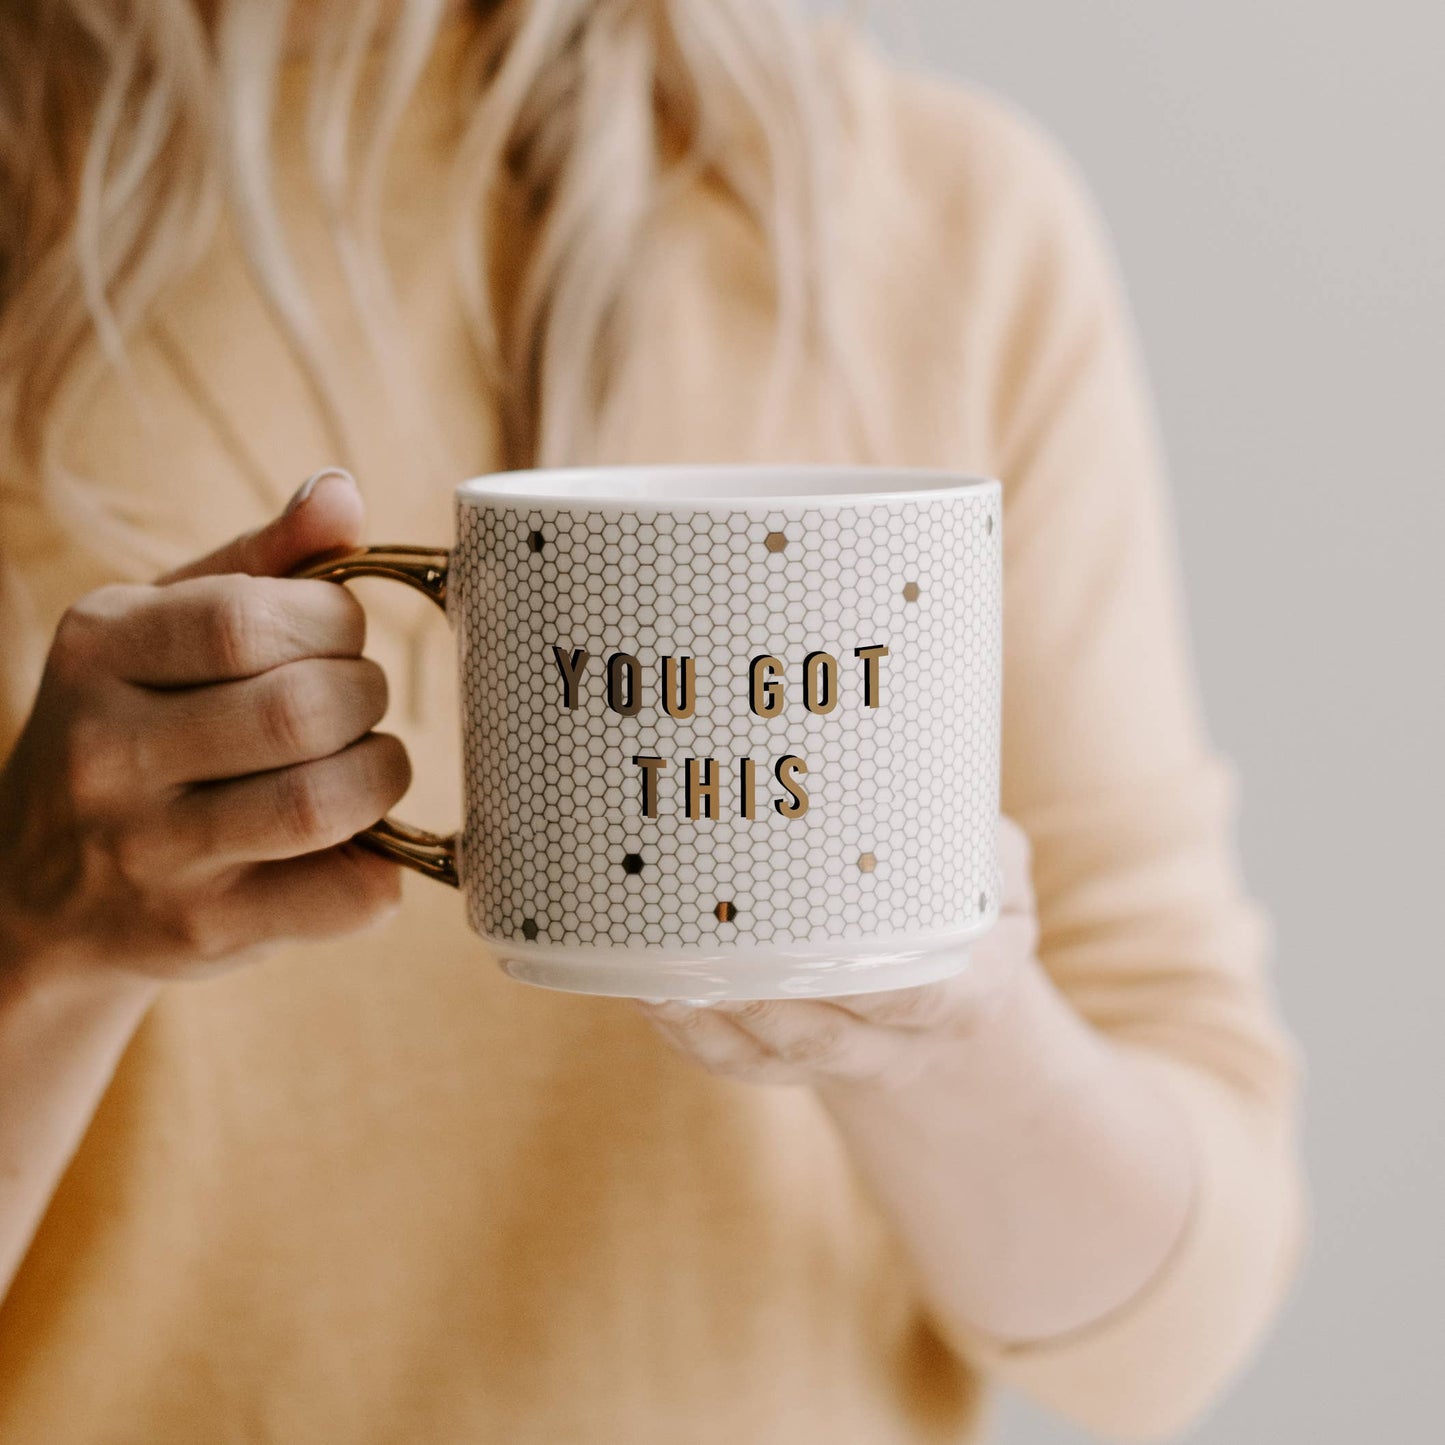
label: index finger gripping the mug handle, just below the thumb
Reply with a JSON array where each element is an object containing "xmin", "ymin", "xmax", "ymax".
[{"xmin": 85, "ymin": 577, "xmax": 366, "ymax": 688}]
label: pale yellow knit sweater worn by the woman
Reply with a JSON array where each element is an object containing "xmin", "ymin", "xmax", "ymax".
[{"xmin": 0, "ymin": 22, "xmax": 1299, "ymax": 1445}]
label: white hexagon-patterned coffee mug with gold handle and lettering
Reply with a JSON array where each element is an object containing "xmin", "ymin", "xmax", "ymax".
[{"xmin": 301, "ymin": 465, "xmax": 1001, "ymax": 1000}]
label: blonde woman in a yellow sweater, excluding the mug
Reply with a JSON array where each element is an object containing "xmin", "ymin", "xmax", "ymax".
[{"xmin": 0, "ymin": 0, "xmax": 1301, "ymax": 1445}]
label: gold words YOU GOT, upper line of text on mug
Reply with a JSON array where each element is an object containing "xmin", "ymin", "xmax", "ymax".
[{"xmin": 552, "ymin": 643, "xmax": 889, "ymax": 718}]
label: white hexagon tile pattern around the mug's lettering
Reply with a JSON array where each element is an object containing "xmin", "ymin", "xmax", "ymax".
[{"xmin": 449, "ymin": 487, "xmax": 1003, "ymax": 949}]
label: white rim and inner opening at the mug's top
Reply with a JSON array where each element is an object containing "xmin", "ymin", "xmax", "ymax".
[{"xmin": 455, "ymin": 462, "xmax": 1001, "ymax": 512}]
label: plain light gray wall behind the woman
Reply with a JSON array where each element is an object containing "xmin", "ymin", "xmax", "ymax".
[{"xmin": 873, "ymin": 0, "xmax": 1445, "ymax": 1445}]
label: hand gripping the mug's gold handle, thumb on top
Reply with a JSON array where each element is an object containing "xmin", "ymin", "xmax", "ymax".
[{"xmin": 0, "ymin": 471, "xmax": 410, "ymax": 980}]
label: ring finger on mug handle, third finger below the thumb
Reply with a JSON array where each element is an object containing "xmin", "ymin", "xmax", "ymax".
[{"xmin": 160, "ymin": 733, "xmax": 412, "ymax": 874}]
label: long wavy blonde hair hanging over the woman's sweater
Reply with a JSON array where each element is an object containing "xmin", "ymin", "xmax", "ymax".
[{"xmin": 0, "ymin": 0, "xmax": 844, "ymax": 569}]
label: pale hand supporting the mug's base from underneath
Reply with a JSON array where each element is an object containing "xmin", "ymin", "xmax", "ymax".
[{"xmin": 637, "ymin": 818, "xmax": 1038, "ymax": 1087}]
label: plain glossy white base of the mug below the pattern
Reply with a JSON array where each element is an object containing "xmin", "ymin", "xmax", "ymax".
[{"xmin": 487, "ymin": 915, "xmax": 997, "ymax": 1003}]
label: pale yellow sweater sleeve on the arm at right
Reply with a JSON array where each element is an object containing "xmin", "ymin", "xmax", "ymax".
[{"xmin": 942, "ymin": 93, "xmax": 1303, "ymax": 1441}]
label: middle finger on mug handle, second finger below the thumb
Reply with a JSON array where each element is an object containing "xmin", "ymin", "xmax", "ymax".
[{"xmin": 140, "ymin": 657, "xmax": 387, "ymax": 785}]
